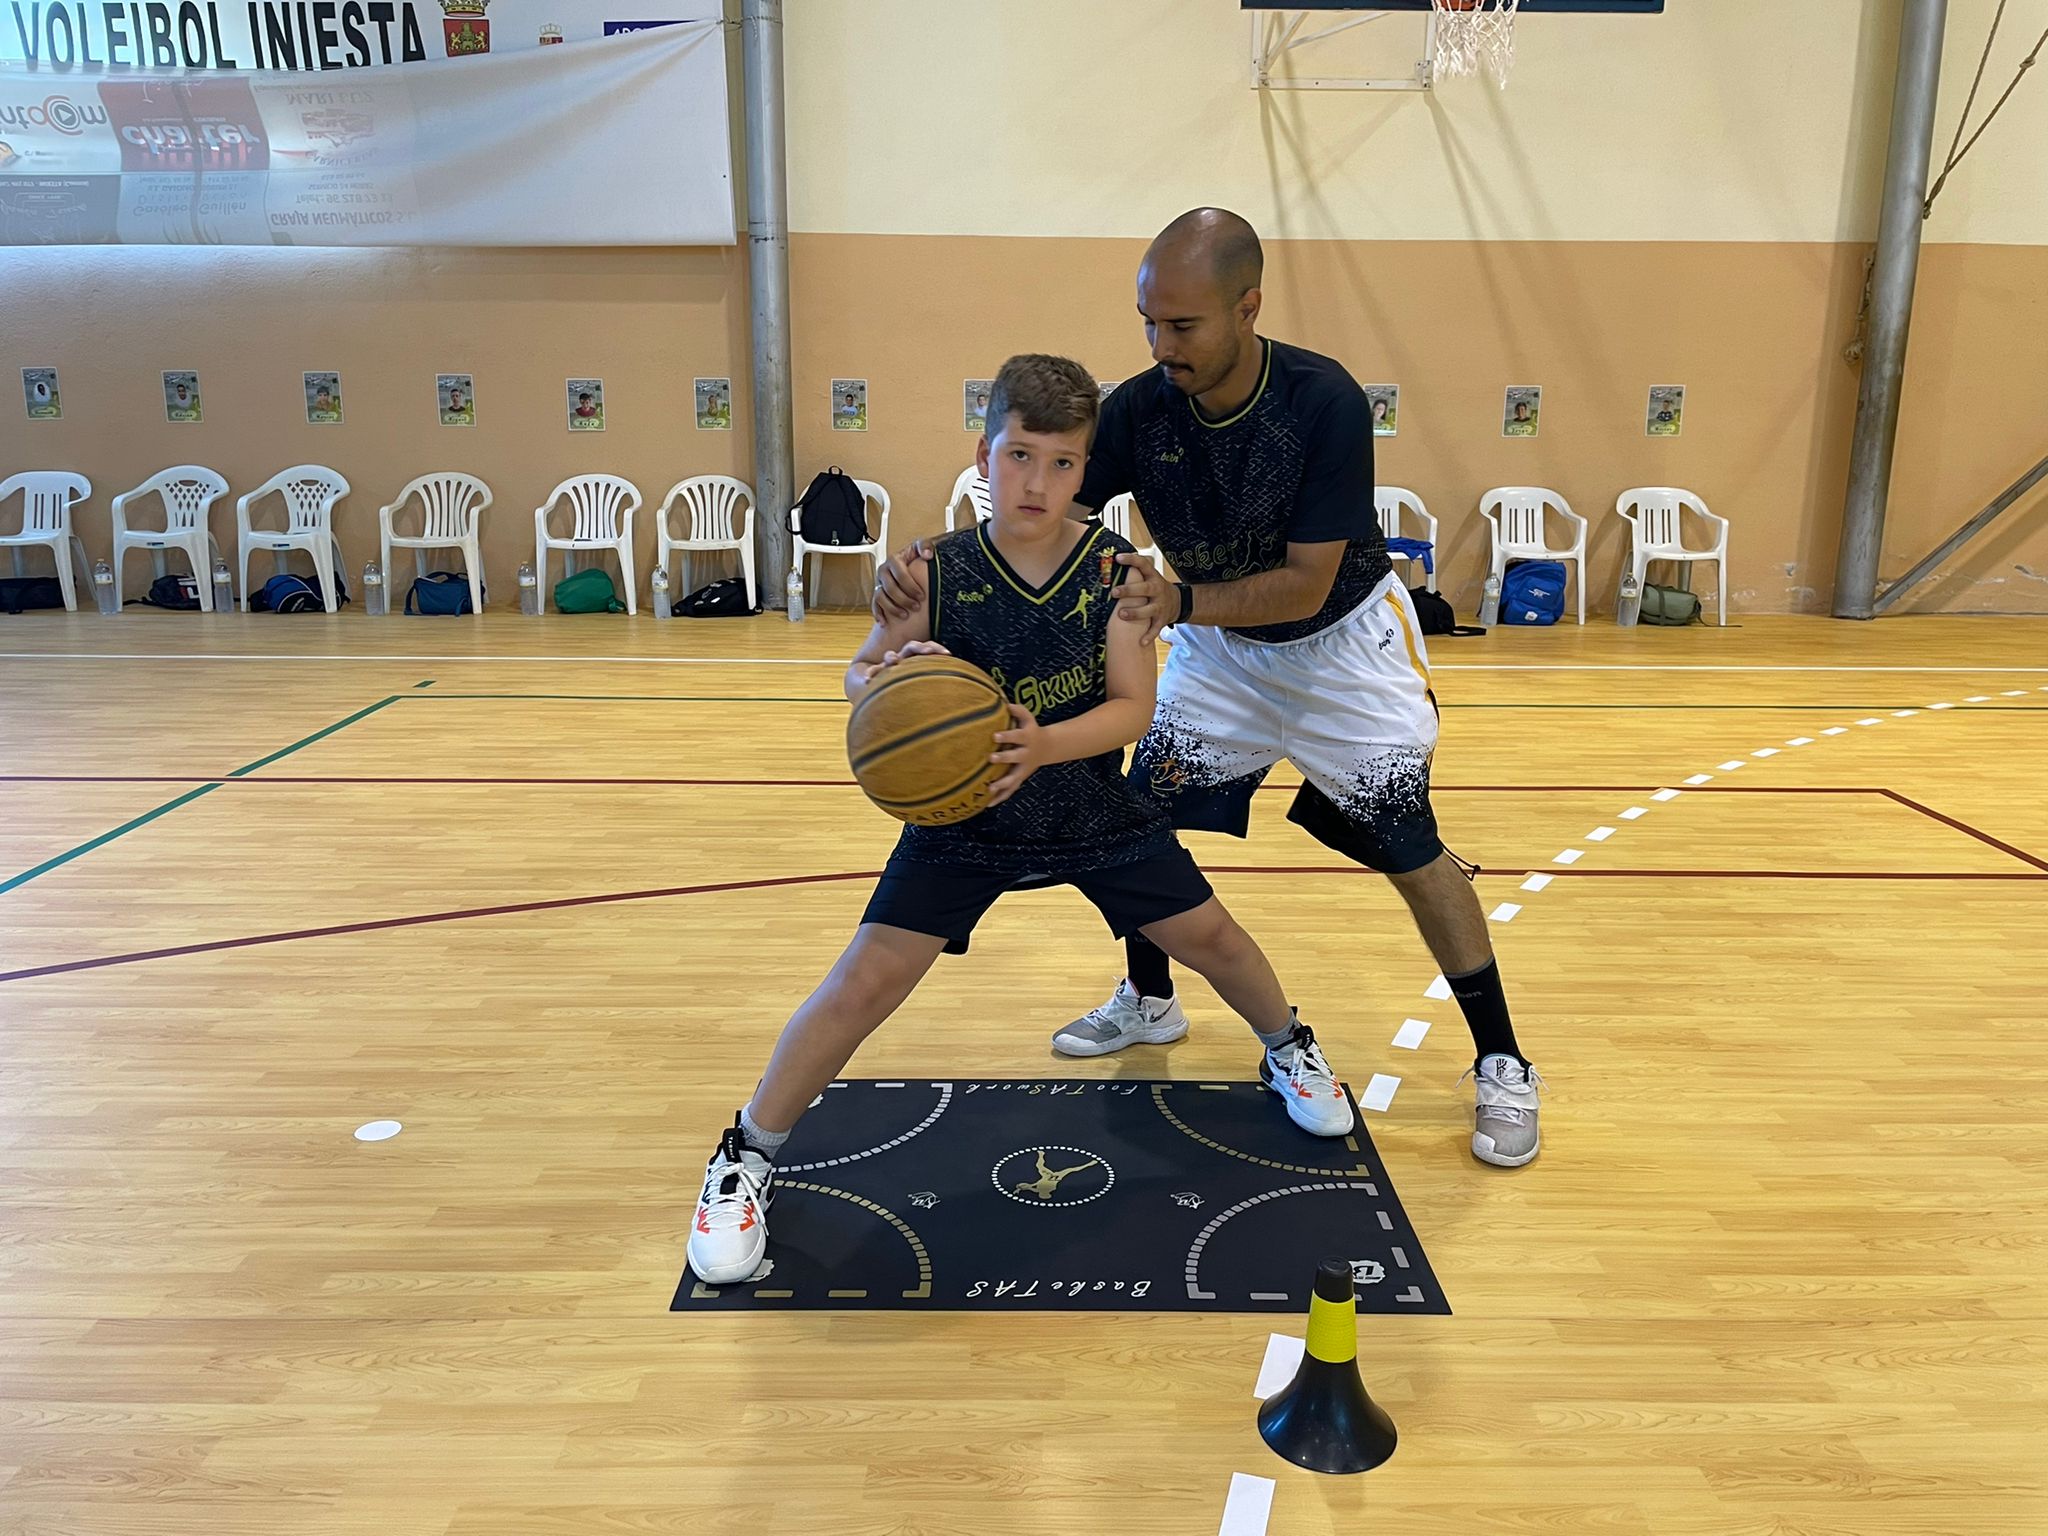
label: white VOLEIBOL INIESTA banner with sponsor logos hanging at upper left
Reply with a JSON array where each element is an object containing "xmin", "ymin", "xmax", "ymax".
[{"xmin": 0, "ymin": 14, "xmax": 735, "ymax": 246}]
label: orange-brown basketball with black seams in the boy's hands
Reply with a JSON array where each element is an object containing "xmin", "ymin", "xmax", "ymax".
[{"xmin": 846, "ymin": 655, "xmax": 1010, "ymax": 827}]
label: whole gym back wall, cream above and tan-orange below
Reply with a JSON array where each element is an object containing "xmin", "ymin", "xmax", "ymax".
[{"xmin": 0, "ymin": 0, "xmax": 2048, "ymax": 612}]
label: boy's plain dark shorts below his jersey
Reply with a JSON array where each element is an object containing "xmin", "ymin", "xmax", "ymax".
[{"xmin": 860, "ymin": 844, "xmax": 1214, "ymax": 954}]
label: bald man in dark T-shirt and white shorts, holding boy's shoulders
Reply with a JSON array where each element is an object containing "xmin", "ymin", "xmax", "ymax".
[{"xmin": 877, "ymin": 209, "xmax": 1540, "ymax": 1167}]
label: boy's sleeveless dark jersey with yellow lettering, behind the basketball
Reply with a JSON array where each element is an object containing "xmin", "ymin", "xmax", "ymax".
[{"xmin": 897, "ymin": 522, "xmax": 1174, "ymax": 877}]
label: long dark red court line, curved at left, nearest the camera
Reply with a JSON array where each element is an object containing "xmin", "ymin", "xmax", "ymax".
[{"xmin": 0, "ymin": 864, "xmax": 2048, "ymax": 981}]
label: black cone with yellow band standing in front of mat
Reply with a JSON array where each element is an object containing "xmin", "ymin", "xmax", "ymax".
[{"xmin": 1260, "ymin": 1260, "xmax": 1399, "ymax": 1473}]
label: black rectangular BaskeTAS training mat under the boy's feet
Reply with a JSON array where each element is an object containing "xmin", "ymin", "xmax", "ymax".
[{"xmin": 670, "ymin": 1077, "xmax": 1450, "ymax": 1313}]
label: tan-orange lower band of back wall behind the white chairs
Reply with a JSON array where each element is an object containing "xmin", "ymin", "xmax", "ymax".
[{"xmin": 0, "ymin": 233, "xmax": 2048, "ymax": 612}]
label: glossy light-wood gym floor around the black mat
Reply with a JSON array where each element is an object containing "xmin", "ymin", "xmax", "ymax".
[{"xmin": 0, "ymin": 614, "xmax": 2048, "ymax": 1536}]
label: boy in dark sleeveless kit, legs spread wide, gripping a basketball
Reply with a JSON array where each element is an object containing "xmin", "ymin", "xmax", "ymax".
[{"xmin": 690, "ymin": 356, "xmax": 1352, "ymax": 1284}]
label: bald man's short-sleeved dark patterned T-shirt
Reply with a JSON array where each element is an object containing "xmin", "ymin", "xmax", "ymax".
[{"xmin": 1075, "ymin": 342, "xmax": 1393, "ymax": 641}]
